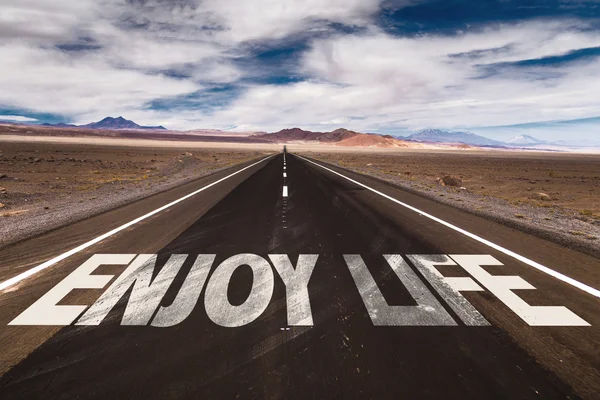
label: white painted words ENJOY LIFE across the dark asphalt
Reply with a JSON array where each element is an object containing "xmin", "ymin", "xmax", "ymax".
[{"xmin": 9, "ymin": 254, "xmax": 589, "ymax": 327}]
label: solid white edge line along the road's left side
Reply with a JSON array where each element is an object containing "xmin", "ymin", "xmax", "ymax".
[{"xmin": 0, "ymin": 156, "xmax": 273, "ymax": 290}]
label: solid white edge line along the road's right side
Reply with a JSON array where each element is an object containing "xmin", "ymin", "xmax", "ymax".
[{"xmin": 297, "ymin": 155, "xmax": 600, "ymax": 298}]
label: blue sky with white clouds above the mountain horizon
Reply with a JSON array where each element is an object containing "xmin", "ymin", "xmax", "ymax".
[{"xmin": 0, "ymin": 0, "xmax": 600, "ymax": 142}]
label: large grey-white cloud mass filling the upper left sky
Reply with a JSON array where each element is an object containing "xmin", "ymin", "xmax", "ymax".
[{"xmin": 0, "ymin": 0, "xmax": 377, "ymax": 125}]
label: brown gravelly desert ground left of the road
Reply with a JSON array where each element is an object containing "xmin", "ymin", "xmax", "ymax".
[{"xmin": 0, "ymin": 142, "xmax": 266, "ymax": 247}]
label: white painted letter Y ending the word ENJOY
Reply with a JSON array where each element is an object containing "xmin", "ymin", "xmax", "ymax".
[{"xmin": 269, "ymin": 254, "xmax": 319, "ymax": 326}]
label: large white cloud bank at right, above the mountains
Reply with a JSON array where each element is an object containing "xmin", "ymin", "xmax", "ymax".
[{"xmin": 196, "ymin": 21, "xmax": 600, "ymax": 134}]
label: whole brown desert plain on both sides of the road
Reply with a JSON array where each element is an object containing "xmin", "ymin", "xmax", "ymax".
[{"xmin": 0, "ymin": 131, "xmax": 600, "ymax": 256}]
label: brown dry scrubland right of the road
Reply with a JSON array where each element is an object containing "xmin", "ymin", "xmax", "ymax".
[{"xmin": 303, "ymin": 149, "xmax": 600, "ymax": 255}]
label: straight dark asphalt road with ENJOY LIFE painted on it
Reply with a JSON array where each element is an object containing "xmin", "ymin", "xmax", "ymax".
[{"xmin": 0, "ymin": 153, "xmax": 600, "ymax": 399}]
